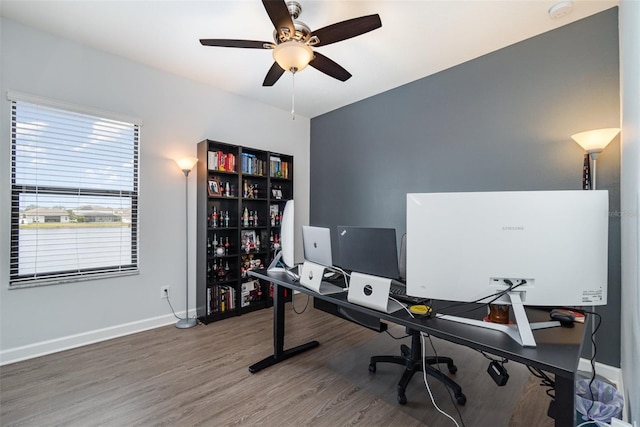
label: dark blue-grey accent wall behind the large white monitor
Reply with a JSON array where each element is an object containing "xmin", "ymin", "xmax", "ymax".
[{"xmin": 309, "ymin": 7, "xmax": 620, "ymax": 367}]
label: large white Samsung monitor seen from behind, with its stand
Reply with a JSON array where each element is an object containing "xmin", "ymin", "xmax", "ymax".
[{"xmin": 407, "ymin": 190, "xmax": 609, "ymax": 347}]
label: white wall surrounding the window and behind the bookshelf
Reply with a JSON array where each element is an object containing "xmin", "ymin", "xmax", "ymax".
[{"xmin": 0, "ymin": 19, "xmax": 309, "ymax": 363}]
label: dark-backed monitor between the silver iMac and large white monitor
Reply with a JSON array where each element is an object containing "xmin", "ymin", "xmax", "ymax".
[{"xmin": 338, "ymin": 225, "xmax": 400, "ymax": 279}]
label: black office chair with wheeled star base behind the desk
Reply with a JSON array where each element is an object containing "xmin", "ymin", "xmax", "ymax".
[{"xmin": 369, "ymin": 234, "xmax": 467, "ymax": 405}]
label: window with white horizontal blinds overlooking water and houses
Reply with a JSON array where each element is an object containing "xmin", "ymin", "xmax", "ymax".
[{"xmin": 9, "ymin": 93, "xmax": 140, "ymax": 288}]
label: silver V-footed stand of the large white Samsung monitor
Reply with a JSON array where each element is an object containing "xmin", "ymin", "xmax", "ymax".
[{"xmin": 436, "ymin": 292, "xmax": 560, "ymax": 347}]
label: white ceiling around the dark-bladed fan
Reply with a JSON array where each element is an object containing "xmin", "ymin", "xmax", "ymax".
[{"xmin": 0, "ymin": 0, "xmax": 618, "ymax": 118}]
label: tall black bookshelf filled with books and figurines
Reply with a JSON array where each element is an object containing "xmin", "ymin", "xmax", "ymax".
[{"xmin": 196, "ymin": 140, "xmax": 293, "ymax": 323}]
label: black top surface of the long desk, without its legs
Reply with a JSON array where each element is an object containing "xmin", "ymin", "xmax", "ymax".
[{"xmin": 249, "ymin": 270, "xmax": 585, "ymax": 381}]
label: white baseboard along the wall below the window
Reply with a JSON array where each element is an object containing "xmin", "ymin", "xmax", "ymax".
[{"xmin": 0, "ymin": 312, "xmax": 195, "ymax": 366}]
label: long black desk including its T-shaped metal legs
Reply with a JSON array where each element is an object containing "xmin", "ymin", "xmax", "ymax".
[{"xmin": 249, "ymin": 270, "xmax": 585, "ymax": 427}]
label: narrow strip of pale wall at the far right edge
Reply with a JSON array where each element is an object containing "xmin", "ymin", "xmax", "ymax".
[{"xmin": 619, "ymin": 0, "xmax": 640, "ymax": 426}]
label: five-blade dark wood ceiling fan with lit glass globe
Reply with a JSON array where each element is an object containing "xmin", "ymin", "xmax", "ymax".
[{"xmin": 200, "ymin": 0, "xmax": 382, "ymax": 86}]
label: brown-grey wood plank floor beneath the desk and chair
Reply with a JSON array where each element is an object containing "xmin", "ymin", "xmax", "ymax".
[{"xmin": 0, "ymin": 295, "xmax": 553, "ymax": 427}]
